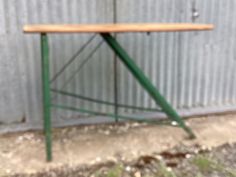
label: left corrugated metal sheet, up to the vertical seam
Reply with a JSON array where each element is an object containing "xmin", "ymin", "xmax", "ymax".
[{"xmin": 0, "ymin": 0, "xmax": 113, "ymax": 126}]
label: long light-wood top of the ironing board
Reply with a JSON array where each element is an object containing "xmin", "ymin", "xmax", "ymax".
[{"xmin": 23, "ymin": 23, "xmax": 214, "ymax": 33}]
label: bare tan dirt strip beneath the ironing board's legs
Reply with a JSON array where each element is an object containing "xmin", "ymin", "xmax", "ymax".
[{"xmin": 0, "ymin": 115, "xmax": 236, "ymax": 176}]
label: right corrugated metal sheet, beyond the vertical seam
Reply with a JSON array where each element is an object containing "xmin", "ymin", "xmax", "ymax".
[{"xmin": 117, "ymin": 0, "xmax": 236, "ymax": 115}]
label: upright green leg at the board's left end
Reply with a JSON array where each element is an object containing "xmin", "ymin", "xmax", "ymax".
[{"xmin": 41, "ymin": 33, "xmax": 52, "ymax": 161}]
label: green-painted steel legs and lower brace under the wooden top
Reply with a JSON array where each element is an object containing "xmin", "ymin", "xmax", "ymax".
[{"xmin": 41, "ymin": 33, "xmax": 195, "ymax": 161}]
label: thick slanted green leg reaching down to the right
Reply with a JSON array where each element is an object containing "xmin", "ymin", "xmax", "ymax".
[{"xmin": 101, "ymin": 33, "xmax": 195, "ymax": 138}]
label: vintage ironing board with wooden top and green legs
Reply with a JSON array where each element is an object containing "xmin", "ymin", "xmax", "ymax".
[{"xmin": 24, "ymin": 23, "xmax": 213, "ymax": 161}]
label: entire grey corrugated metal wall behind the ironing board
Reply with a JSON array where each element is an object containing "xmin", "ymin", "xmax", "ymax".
[{"xmin": 0, "ymin": 0, "xmax": 236, "ymax": 130}]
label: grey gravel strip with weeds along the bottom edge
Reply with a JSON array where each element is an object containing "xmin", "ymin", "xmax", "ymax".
[{"xmin": 5, "ymin": 143, "xmax": 236, "ymax": 177}]
